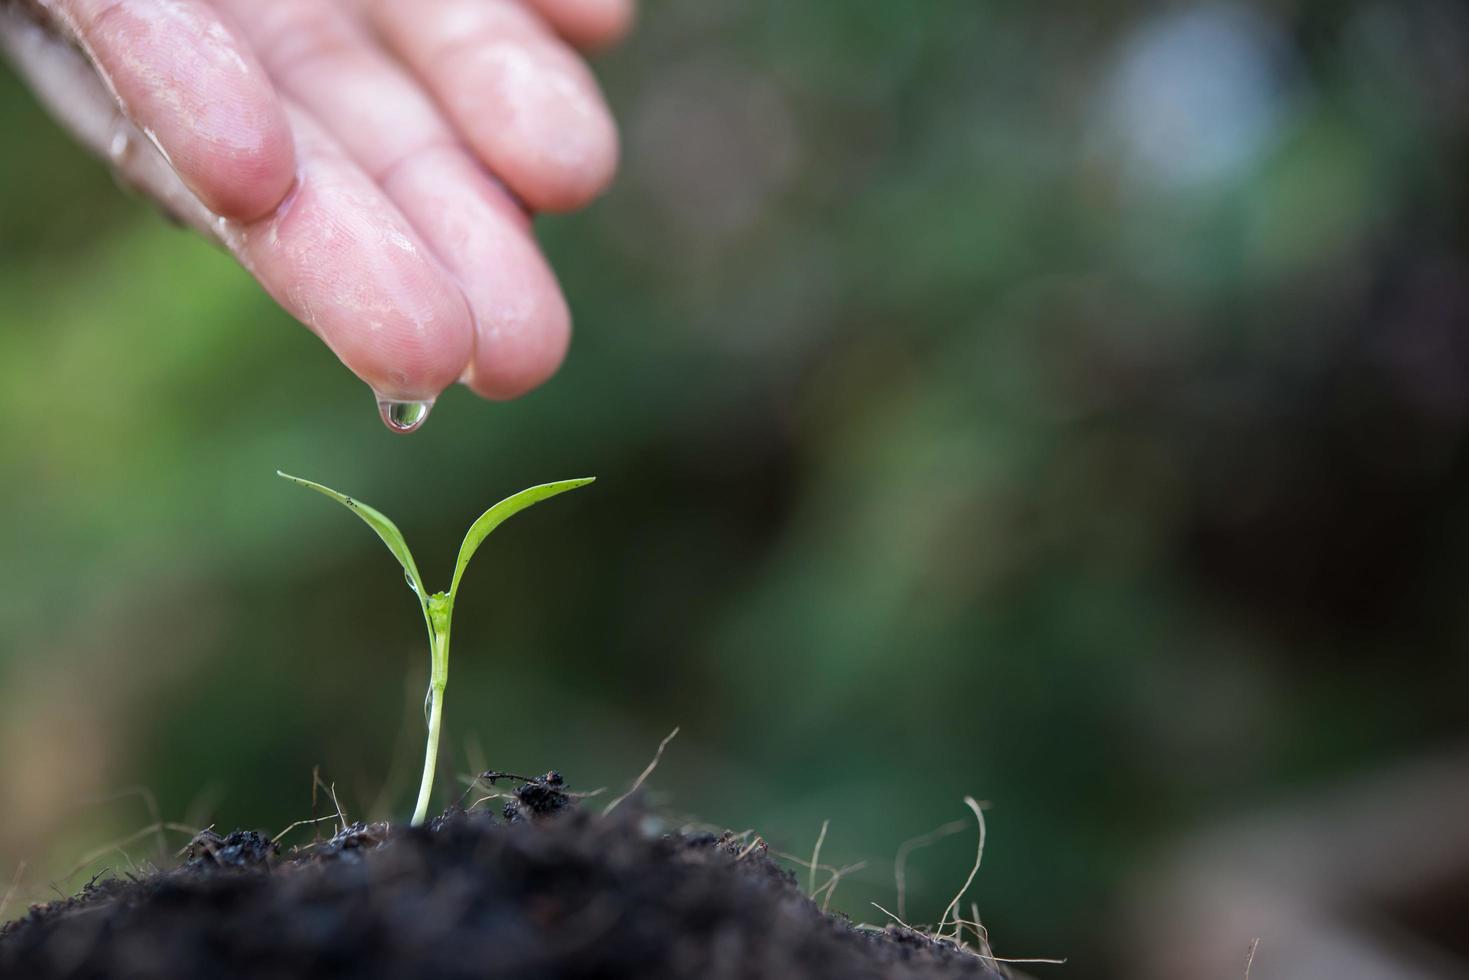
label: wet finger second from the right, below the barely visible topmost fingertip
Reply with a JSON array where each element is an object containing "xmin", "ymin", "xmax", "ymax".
[{"xmin": 369, "ymin": 0, "xmax": 617, "ymax": 210}]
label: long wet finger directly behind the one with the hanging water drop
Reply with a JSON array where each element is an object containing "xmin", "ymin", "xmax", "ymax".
[{"xmin": 225, "ymin": 0, "xmax": 570, "ymax": 398}]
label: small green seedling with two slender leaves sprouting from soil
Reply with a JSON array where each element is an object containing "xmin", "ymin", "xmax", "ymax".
[{"xmin": 276, "ymin": 470, "xmax": 595, "ymax": 826}]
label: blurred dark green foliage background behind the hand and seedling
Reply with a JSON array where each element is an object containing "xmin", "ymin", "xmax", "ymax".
[{"xmin": 0, "ymin": 0, "xmax": 1469, "ymax": 977}]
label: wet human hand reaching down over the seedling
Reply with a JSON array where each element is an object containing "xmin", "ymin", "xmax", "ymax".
[{"xmin": 0, "ymin": 0, "xmax": 633, "ymax": 428}]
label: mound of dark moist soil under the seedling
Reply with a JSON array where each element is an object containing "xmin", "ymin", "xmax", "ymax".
[{"xmin": 0, "ymin": 773, "xmax": 1002, "ymax": 980}]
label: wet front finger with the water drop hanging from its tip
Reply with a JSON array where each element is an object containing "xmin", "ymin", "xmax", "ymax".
[{"xmin": 229, "ymin": 109, "xmax": 473, "ymax": 401}]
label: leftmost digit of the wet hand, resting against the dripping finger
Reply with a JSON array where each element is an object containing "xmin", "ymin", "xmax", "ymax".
[{"xmin": 56, "ymin": 0, "xmax": 295, "ymax": 220}]
